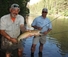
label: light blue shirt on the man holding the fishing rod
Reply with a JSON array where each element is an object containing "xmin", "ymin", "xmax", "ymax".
[{"xmin": 31, "ymin": 16, "xmax": 52, "ymax": 32}]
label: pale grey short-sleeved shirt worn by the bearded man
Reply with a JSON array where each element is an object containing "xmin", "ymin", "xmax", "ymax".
[{"xmin": 0, "ymin": 14, "xmax": 24, "ymax": 38}]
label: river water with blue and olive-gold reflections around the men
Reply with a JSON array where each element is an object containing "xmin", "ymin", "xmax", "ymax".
[{"xmin": 23, "ymin": 15, "xmax": 68, "ymax": 57}]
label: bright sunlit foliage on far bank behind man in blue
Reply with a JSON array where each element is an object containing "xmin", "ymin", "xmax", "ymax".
[{"xmin": 30, "ymin": 0, "xmax": 68, "ymax": 16}]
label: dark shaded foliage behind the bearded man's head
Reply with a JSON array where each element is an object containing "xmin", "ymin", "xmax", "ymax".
[{"xmin": 0, "ymin": 0, "xmax": 30, "ymax": 17}]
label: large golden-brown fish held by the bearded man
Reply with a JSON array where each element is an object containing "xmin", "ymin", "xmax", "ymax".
[{"xmin": 10, "ymin": 30, "xmax": 44, "ymax": 45}]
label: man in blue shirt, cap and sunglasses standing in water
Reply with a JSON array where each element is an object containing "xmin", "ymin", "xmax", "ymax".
[{"xmin": 31, "ymin": 8, "xmax": 52, "ymax": 57}]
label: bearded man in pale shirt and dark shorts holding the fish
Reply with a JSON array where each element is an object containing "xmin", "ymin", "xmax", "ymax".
[{"xmin": 0, "ymin": 4, "xmax": 30, "ymax": 57}]
